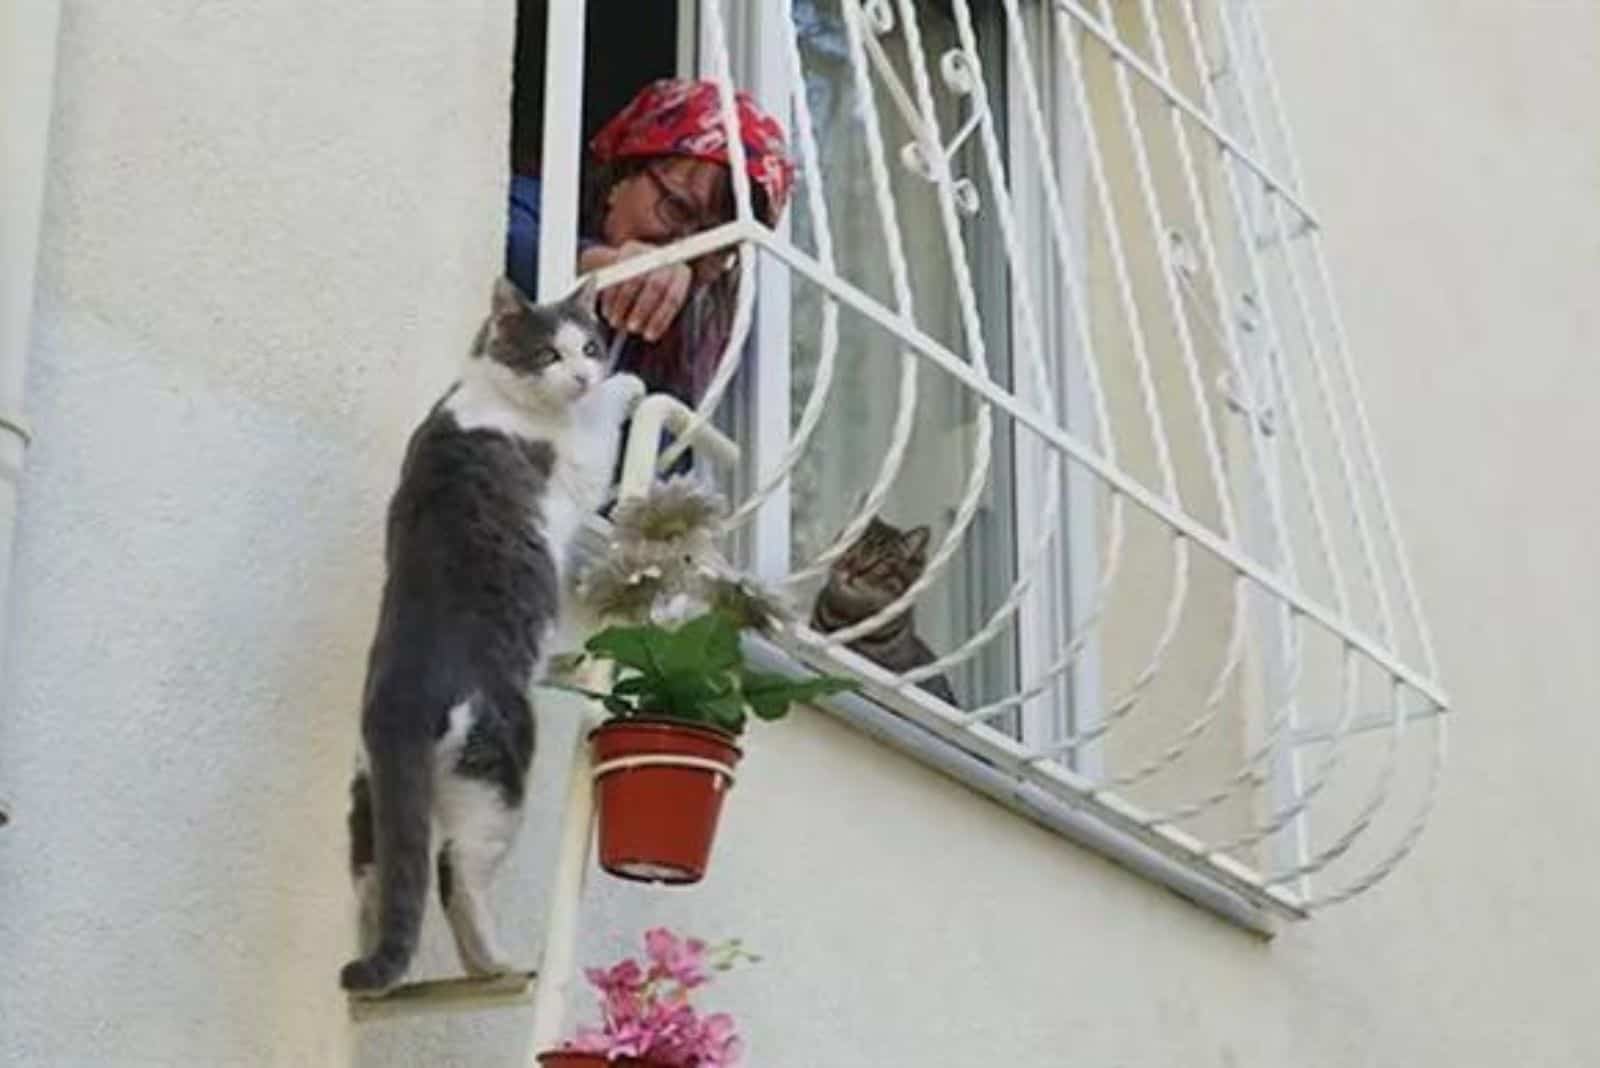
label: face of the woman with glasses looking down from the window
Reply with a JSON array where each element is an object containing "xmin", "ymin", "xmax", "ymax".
[{"xmin": 600, "ymin": 157, "xmax": 731, "ymax": 246}]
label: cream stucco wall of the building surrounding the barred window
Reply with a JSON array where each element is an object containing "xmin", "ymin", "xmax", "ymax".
[{"xmin": 0, "ymin": 0, "xmax": 1600, "ymax": 1068}]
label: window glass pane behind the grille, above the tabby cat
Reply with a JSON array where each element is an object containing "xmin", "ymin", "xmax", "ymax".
[{"xmin": 790, "ymin": 0, "xmax": 1016, "ymax": 707}]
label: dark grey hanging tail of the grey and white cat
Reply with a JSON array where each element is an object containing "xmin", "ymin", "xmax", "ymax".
[{"xmin": 339, "ymin": 716, "xmax": 434, "ymax": 993}]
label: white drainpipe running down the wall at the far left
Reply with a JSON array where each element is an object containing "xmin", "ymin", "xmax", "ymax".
[{"xmin": 0, "ymin": 0, "xmax": 61, "ymax": 827}]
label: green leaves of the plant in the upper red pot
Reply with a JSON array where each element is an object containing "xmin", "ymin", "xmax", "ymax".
[{"xmin": 579, "ymin": 611, "xmax": 856, "ymax": 734}]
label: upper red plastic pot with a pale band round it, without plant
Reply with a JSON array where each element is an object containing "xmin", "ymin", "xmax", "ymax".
[{"xmin": 589, "ymin": 719, "xmax": 742, "ymax": 884}]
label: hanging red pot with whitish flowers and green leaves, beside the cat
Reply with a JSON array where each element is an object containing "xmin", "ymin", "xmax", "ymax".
[{"xmin": 552, "ymin": 478, "xmax": 854, "ymax": 884}]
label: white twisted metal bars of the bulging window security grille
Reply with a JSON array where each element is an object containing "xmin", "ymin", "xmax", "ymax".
[{"xmin": 610, "ymin": 0, "xmax": 1446, "ymax": 915}]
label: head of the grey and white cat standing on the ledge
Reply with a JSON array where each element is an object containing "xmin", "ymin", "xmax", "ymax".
[{"xmin": 480, "ymin": 278, "xmax": 605, "ymax": 408}]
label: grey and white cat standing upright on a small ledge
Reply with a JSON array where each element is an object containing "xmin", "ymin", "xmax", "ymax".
[{"xmin": 339, "ymin": 278, "xmax": 645, "ymax": 993}]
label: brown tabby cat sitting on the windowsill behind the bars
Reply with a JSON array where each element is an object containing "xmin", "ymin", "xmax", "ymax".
[{"xmin": 811, "ymin": 516, "xmax": 957, "ymax": 705}]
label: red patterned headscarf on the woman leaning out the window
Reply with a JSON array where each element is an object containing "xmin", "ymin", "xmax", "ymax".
[{"xmin": 589, "ymin": 78, "xmax": 795, "ymax": 225}]
